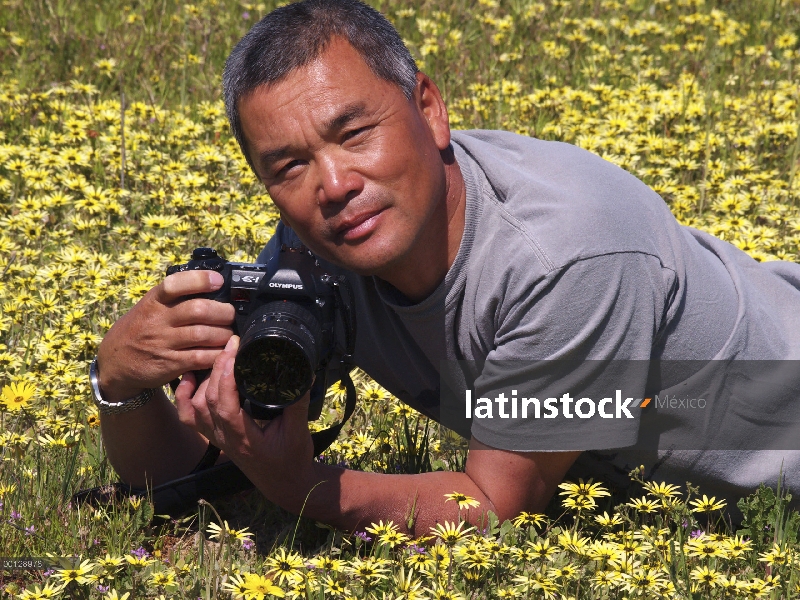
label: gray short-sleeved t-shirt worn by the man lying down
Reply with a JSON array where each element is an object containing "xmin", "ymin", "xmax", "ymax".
[{"xmin": 259, "ymin": 131, "xmax": 800, "ymax": 506}]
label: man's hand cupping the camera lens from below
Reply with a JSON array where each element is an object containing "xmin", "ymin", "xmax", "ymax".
[{"xmin": 175, "ymin": 336, "xmax": 314, "ymax": 505}]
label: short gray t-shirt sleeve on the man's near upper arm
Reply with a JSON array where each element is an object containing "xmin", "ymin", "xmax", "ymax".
[{"xmin": 472, "ymin": 252, "xmax": 675, "ymax": 451}]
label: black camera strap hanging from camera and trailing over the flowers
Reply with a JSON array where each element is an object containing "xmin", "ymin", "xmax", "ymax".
[{"xmin": 72, "ymin": 372, "xmax": 356, "ymax": 517}]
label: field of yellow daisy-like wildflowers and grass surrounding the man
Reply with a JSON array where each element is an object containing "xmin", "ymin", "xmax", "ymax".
[{"xmin": 0, "ymin": 0, "xmax": 800, "ymax": 600}]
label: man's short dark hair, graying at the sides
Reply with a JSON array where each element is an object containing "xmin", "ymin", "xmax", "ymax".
[{"xmin": 222, "ymin": 0, "xmax": 419, "ymax": 167}]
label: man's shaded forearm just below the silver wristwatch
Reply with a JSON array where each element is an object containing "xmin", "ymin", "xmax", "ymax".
[{"xmin": 100, "ymin": 390, "xmax": 208, "ymax": 487}]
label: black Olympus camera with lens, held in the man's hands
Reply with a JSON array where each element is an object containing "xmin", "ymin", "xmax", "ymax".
[{"xmin": 167, "ymin": 245, "xmax": 355, "ymax": 419}]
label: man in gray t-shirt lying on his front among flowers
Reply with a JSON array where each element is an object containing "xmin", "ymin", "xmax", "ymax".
[{"xmin": 96, "ymin": 0, "xmax": 800, "ymax": 535}]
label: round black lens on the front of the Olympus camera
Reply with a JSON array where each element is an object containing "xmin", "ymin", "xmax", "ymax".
[{"xmin": 234, "ymin": 300, "xmax": 322, "ymax": 419}]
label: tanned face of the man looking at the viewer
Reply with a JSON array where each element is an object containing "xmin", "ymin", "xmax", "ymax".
[{"xmin": 234, "ymin": 38, "xmax": 450, "ymax": 279}]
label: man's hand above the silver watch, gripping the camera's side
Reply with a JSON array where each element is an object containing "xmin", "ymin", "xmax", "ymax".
[{"xmin": 97, "ymin": 270, "xmax": 235, "ymax": 402}]
